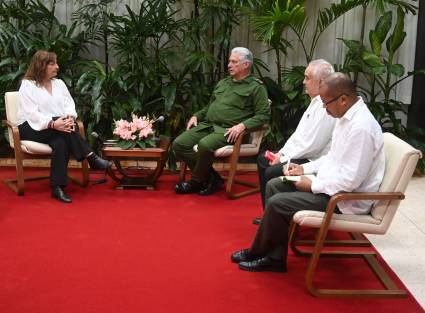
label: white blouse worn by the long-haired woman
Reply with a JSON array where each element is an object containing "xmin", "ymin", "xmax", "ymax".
[{"xmin": 17, "ymin": 79, "xmax": 77, "ymax": 130}]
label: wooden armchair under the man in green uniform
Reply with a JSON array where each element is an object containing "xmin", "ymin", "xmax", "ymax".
[{"xmin": 180, "ymin": 126, "xmax": 268, "ymax": 199}]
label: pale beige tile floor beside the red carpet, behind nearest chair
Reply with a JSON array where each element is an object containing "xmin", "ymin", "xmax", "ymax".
[{"xmin": 368, "ymin": 176, "xmax": 425, "ymax": 308}]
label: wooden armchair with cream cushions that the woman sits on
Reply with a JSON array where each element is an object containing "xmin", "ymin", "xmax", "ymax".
[{"xmin": 3, "ymin": 91, "xmax": 89, "ymax": 196}]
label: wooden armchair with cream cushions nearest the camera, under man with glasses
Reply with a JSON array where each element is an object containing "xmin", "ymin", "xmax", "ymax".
[{"xmin": 289, "ymin": 133, "xmax": 422, "ymax": 297}]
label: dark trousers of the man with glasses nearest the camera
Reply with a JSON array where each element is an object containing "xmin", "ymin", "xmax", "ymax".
[{"xmin": 249, "ymin": 178, "xmax": 332, "ymax": 265}]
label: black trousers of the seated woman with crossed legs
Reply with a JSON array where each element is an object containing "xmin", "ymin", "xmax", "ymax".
[{"xmin": 18, "ymin": 122, "xmax": 93, "ymax": 187}]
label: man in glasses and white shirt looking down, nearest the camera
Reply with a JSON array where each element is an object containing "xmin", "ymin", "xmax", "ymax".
[{"xmin": 231, "ymin": 73, "xmax": 385, "ymax": 272}]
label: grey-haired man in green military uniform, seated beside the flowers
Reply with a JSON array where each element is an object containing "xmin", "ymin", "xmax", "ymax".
[{"xmin": 173, "ymin": 47, "xmax": 270, "ymax": 195}]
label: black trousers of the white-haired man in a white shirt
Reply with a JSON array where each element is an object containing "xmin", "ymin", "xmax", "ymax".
[{"xmin": 257, "ymin": 152, "xmax": 309, "ymax": 210}]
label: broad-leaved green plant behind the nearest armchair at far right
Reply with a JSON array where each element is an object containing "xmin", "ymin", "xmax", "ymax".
[{"xmin": 342, "ymin": 7, "xmax": 425, "ymax": 170}]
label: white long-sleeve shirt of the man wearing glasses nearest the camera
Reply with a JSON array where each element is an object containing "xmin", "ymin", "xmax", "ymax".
[{"xmin": 303, "ymin": 97, "xmax": 385, "ymax": 214}]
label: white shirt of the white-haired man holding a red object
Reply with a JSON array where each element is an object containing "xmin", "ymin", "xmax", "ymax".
[{"xmin": 279, "ymin": 96, "xmax": 336, "ymax": 162}]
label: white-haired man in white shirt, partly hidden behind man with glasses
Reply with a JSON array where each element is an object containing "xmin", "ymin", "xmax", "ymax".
[{"xmin": 253, "ymin": 59, "xmax": 336, "ymax": 224}]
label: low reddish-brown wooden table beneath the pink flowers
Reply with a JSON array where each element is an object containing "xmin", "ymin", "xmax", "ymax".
[{"xmin": 102, "ymin": 137, "xmax": 170, "ymax": 189}]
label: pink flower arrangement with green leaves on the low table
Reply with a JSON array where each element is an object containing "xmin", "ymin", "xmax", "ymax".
[{"xmin": 113, "ymin": 114, "xmax": 155, "ymax": 149}]
